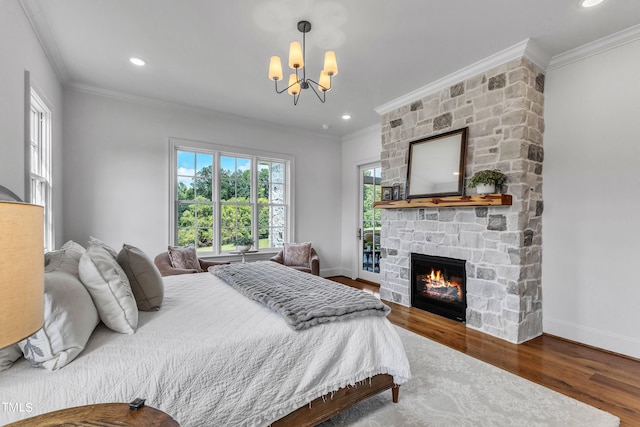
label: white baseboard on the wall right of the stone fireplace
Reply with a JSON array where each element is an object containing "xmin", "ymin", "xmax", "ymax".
[{"xmin": 543, "ymin": 317, "xmax": 640, "ymax": 359}]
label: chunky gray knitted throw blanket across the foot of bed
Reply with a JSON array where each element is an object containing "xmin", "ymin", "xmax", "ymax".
[{"xmin": 209, "ymin": 261, "xmax": 391, "ymax": 330}]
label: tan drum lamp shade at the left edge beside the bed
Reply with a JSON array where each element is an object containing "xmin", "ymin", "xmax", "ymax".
[{"xmin": 0, "ymin": 202, "xmax": 44, "ymax": 348}]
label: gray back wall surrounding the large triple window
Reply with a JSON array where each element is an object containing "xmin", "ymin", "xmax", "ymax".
[{"xmin": 64, "ymin": 89, "xmax": 341, "ymax": 275}]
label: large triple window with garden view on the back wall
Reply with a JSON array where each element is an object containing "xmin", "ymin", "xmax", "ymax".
[{"xmin": 171, "ymin": 140, "xmax": 293, "ymax": 255}]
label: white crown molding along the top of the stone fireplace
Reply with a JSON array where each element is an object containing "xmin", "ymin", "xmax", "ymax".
[{"xmin": 375, "ymin": 39, "xmax": 549, "ymax": 115}]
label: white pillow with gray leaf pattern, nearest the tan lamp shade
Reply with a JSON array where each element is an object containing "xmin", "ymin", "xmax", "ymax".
[{"xmin": 18, "ymin": 271, "xmax": 100, "ymax": 371}]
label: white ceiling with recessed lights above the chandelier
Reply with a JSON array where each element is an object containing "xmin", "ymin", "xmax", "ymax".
[{"xmin": 21, "ymin": 0, "xmax": 640, "ymax": 136}]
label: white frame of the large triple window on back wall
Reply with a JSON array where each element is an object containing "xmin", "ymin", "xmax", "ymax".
[{"xmin": 169, "ymin": 138, "xmax": 295, "ymax": 257}]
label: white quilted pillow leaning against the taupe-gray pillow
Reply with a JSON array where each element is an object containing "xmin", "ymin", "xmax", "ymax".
[{"xmin": 79, "ymin": 244, "xmax": 138, "ymax": 334}]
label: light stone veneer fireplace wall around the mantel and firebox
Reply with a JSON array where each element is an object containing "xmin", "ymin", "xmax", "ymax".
[{"xmin": 380, "ymin": 57, "xmax": 544, "ymax": 343}]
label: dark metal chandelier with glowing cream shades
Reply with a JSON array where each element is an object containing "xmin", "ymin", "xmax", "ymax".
[{"xmin": 269, "ymin": 21, "xmax": 338, "ymax": 105}]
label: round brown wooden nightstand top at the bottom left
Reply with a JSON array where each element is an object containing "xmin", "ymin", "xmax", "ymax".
[{"xmin": 6, "ymin": 403, "xmax": 180, "ymax": 427}]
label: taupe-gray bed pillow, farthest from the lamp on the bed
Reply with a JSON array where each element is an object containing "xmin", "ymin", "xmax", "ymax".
[{"xmin": 116, "ymin": 244, "xmax": 164, "ymax": 311}]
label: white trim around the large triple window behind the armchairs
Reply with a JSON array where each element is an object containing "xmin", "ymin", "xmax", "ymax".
[{"xmin": 169, "ymin": 138, "xmax": 296, "ymax": 257}]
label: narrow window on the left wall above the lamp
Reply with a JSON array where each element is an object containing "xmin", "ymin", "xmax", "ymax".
[{"xmin": 28, "ymin": 89, "xmax": 53, "ymax": 250}]
